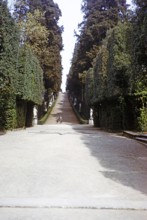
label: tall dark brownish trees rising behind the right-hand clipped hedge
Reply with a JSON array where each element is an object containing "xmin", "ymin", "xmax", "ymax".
[{"xmin": 68, "ymin": 0, "xmax": 126, "ymax": 118}]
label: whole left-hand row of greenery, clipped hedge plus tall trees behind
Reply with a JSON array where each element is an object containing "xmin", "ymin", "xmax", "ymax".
[{"xmin": 0, "ymin": 0, "xmax": 63, "ymax": 130}]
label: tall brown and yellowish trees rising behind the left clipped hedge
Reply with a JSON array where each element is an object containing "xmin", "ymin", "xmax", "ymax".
[{"xmin": 15, "ymin": 0, "xmax": 63, "ymax": 117}]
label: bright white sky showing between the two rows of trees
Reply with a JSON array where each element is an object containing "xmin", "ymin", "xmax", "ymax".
[{"xmin": 8, "ymin": 0, "xmax": 132, "ymax": 91}]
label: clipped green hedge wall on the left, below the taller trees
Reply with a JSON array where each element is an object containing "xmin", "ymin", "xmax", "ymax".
[{"xmin": 0, "ymin": 1, "xmax": 44, "ymax": 129}]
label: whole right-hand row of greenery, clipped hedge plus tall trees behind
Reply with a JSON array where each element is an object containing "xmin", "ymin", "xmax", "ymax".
[{"xmin": 67, "ymin": 0, "xmax": 147, "ymax": 131}]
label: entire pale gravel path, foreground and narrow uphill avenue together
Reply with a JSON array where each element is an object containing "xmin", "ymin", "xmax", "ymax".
[{"xmin": 0, "ymin": 93, "xmax": 147, "ymax": 220}]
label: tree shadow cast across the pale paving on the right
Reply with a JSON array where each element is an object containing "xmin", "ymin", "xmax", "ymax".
[{"xmin": 73, "ymin": 126, "xmax": 147, "ymax": 195}]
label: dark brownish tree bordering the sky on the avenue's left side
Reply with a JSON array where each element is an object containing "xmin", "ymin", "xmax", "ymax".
[{"xmin": 15, "ymin": 0, "xmax": 63, "ymax": 92}]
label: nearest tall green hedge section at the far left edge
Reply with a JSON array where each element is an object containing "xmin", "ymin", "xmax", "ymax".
[{"xmin": 0, "ymin": 1, "xmax": 19, "ymax": 129}]
